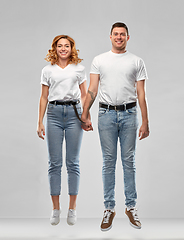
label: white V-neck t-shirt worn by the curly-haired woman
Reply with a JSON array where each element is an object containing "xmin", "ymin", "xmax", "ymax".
[{"xmin": 41, "ymin": 64, "xmax": 86, "ymax": 102}]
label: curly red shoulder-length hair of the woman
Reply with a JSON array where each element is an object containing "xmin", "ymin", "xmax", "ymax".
[{"xmin": 45, "ymin": 35, "xmax": 83, "ymax": 65}]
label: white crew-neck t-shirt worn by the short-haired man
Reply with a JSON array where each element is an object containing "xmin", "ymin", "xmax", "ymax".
[{"xmin": 90, "ymin": 51, "xmax": 148, "ymax": 105}]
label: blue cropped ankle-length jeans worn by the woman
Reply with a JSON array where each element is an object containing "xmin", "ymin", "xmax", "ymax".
[{"xmin": 46, "ymin": 103, "xmax": 83, "ymax": 196}]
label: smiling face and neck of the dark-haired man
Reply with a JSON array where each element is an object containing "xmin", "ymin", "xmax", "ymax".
[{"xmin": 110, "ymin": 27, "xmax": 130, "ymax": 51}]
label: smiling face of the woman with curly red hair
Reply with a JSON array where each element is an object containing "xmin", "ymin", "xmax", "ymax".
[{"xmin": 56, "ymin": 38, "xmax": 72, "ymax": 60}]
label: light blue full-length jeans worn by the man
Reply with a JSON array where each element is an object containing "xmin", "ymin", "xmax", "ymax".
[{"xmin": 98, "ymin": 107, "xmax": 138, "ymax": 209}]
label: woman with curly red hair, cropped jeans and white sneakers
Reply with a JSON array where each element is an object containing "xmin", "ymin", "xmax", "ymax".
[{"xmin": 37, "ymin": 35, "xmax": 87, "ymax": 225}]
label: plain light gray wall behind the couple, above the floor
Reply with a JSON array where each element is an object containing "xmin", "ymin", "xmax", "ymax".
[{"xmin": 0, "ymin": 0, "xmax": 184, "ymax": 218}]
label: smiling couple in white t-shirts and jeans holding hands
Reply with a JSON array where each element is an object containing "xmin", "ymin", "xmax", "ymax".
[{"xmin": 37, "ymin": 22, "xmax": 149, "ymax": 231}]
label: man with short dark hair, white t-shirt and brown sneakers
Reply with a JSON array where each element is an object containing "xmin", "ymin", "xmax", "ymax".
[{"xmin": 81, "ymin": 22, "xmax": 149, "ymax": 231}]
